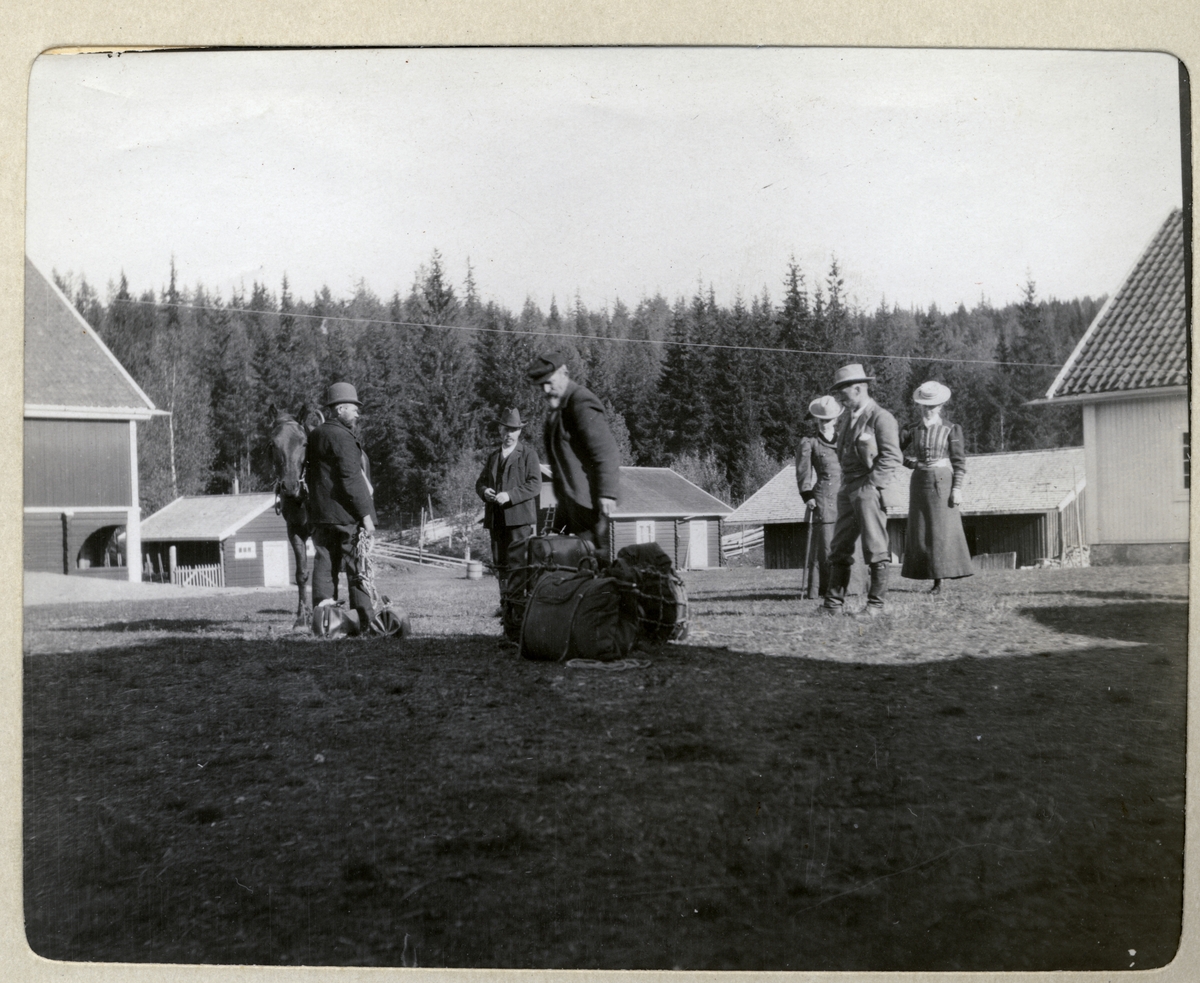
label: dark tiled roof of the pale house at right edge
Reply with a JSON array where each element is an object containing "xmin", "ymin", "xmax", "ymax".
[{"xmin": 1046, "ymin": 209, "xmax": 1188, "ymax": 397}]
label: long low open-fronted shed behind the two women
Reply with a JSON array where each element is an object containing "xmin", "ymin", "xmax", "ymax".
[{"xmin": 726, "ymin": 448, "xmax": 1087, "ymax": 569}]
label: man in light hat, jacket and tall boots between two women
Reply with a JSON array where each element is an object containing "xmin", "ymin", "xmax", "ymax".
[{"xmin": 823, "ymin": 364, "xmax": 904, "ymax": 616}]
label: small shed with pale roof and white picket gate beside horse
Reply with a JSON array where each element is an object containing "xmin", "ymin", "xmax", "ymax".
[{"xmin": 142, "ymin": 492, "xmax": 304, "ymax": 587}]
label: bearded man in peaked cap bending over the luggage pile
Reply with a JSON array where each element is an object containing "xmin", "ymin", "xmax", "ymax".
[{"xmin": 526, "ymin": 352, "xmax": 620, "ymax": 546}]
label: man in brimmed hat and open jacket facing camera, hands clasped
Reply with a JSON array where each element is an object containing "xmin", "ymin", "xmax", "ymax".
[{"xmin": 475, "ymin": 409, "xmax": 541, "ymax": 601}]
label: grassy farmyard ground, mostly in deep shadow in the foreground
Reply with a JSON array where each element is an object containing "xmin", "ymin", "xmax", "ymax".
[{"xmin": 24, "ymin": 568, "xmax": 1188, "ymax": 970}]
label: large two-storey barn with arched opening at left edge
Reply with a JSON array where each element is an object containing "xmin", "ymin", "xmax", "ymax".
[{"xmin": 23, "ymin": 257, "xmax": 162, "ymax": 581}]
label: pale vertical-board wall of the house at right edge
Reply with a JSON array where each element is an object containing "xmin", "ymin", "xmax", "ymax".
[{"xmin": 1084, "ymin": 396, "xmax": 1189, "ymax": 544}]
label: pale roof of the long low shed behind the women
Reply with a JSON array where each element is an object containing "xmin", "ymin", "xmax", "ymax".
[{"xmin": 725, "ymin": 448, "xmax": 1084, "ymax": 525}]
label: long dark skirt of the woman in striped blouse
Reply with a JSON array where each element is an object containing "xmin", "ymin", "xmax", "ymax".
[{"xmin": 900, "ymin": 467, "xmax": 974, "ymax": 580}]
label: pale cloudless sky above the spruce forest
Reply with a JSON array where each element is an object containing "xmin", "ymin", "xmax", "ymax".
[{"xmin": 26, "ymin": 48, "xmax": 1182, "ymax": 311}]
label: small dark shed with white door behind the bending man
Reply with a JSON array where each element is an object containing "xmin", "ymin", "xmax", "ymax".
[{"xmin": 539, "ymin": 464, "xmax": 733, "ymax": 570}]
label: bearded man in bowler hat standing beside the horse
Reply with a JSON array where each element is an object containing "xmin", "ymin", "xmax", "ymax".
[{"xmin": 307, "ymin": 382, "xmax": 376, "ymax": 627}]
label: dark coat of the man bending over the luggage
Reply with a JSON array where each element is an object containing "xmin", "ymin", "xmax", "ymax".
[{"xmin": 546, "ymin": 382, "xmax": 620, "ymax": 509}]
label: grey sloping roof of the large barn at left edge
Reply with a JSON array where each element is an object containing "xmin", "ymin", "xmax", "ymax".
[{"xmin": 25, "ymin": 256, "xmax": 157, "ymax": 420}]
